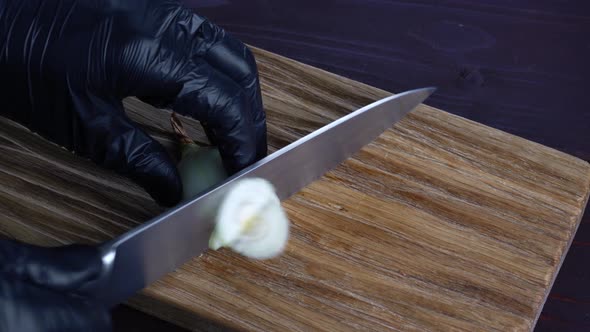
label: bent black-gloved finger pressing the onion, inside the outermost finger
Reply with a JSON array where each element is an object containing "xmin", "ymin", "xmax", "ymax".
[{"xmin": 173, "ymin": 59, "xmax": 257, "ymax": 174}]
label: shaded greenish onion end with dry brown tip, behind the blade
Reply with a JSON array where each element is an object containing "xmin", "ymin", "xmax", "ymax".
[{"xmin": 170, "ymin": 113, "xmax": 228, "ymax": 200}]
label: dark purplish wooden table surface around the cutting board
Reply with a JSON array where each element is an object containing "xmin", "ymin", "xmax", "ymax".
[{"xmin": 114, "ymin": 0, "xmax": 590, "ymax": 331}]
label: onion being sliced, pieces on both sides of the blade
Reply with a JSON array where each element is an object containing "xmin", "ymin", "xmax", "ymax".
[{"xmin": 171, "ymin": 113, "xmax": 289, "ymax": 259}]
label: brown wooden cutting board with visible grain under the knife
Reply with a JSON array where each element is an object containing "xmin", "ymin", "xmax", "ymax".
[{"xmin": 0, "ymin": 49, "xmax": 590, "ymax": 331}]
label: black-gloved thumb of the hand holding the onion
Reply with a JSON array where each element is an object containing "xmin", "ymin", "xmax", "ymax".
[{"xmin": 76, "ymin": 92, "xmax": 182, "ymax": 206}]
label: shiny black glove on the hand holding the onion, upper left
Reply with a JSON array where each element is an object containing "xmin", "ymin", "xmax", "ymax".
[{"xmin": 0, "ymin": 0, "xmax": 267, "ymax": 206}]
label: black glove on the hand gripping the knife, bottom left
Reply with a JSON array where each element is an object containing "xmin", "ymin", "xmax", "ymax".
[{"xmin": 0, "ymin": 240, "xmax": 111, "ymax": 332}]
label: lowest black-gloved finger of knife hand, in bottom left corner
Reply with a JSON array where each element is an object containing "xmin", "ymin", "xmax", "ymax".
[{"xmin": 0, "ymin": 276, "xmax": 111, "ymax": 332}]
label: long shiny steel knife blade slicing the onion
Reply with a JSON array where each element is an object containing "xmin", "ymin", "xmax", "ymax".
[{"xmin": 80, "ymin": 88, "xmax": 435, "ymax": 307}]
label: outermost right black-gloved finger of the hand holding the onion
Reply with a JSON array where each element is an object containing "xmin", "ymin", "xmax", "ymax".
[{"xmin": 192, "ymin": 18, "xmax": 267, "ymax": 159}]
